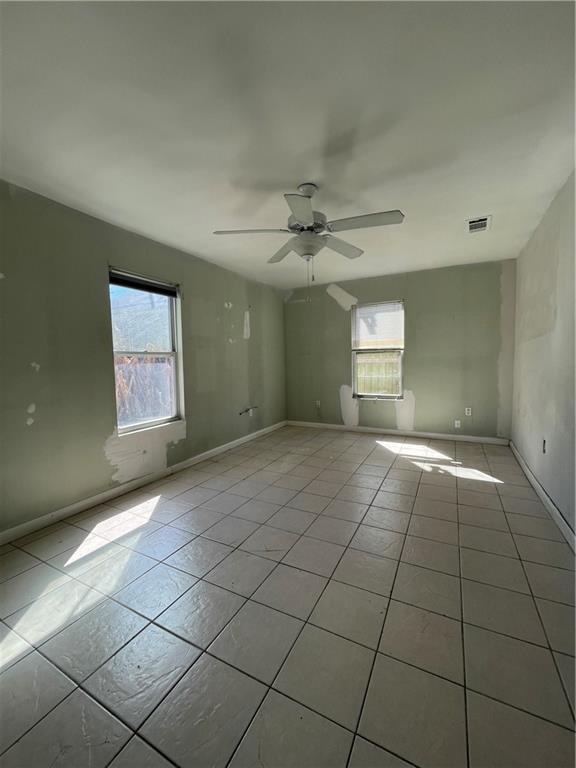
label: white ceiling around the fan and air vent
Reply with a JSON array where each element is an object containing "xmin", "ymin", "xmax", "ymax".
[{"xmin": 2, "ymin": 2, "xmax": 574, "ymax": 288}]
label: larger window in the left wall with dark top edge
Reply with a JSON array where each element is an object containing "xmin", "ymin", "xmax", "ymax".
[{"xmin": 110, "ymin": 272, "xmax": 179, "ymax": 431}]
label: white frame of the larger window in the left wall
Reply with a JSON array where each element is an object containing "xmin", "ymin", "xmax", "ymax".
[{"xmin": 108, "ymin": 267, "xmax": 184, "ymax": 435}]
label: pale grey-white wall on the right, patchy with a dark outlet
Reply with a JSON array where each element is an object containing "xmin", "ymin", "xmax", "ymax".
[{"xmin": 512, "ymin": 174, "xmax": 575, "ymax": 530}]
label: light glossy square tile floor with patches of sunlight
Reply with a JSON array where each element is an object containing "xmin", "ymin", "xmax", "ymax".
[{"xmin": 0, "ymin": 428, "xmax": 574, "ymax": 768}]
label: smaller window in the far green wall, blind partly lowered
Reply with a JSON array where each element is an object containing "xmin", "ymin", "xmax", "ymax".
[{"xmin": 352, "ymin": 301, "xmax": 404, "ymax": 398}]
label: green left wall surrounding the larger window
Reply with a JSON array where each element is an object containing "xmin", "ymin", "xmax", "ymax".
[{"xmin": 0, "ymin": 182, "xmax": 285, "ymax": 529}]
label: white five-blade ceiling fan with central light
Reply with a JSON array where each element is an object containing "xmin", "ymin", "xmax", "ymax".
[{"xmin": 214, "ymin": 183, "xmax": 404, "ymax": 264}]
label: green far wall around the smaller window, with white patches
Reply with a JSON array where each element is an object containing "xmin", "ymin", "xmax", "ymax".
[{"xmin": 285, "ymin": 260, "xmax": 515, "ymax": 437}]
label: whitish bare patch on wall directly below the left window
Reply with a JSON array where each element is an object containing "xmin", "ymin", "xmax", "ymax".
[{"xmin": 104, "ymin": 421, "xmax": 186, "ymax": 483}]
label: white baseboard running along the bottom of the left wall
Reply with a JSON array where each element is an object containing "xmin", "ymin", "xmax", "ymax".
[{"xmin": 0, "ymin": 421, "xmax": 287, "ymax": 544}]
